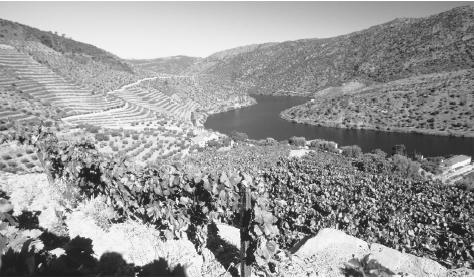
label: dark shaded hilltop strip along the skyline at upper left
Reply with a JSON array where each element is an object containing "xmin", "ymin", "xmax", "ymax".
[{"xmin": 0, "ymin": 16, "xmax": 132, "ymax": 72}]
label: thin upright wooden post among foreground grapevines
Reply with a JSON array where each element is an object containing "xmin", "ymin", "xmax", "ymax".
[{"xmin": 240, "ymin": 181, "xmax": 251, "ymax": 277}]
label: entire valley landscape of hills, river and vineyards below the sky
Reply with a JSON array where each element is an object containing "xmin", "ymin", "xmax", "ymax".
[{"xmin": 0, "ymin": 3, "xmax": 474, "ymax": 277}]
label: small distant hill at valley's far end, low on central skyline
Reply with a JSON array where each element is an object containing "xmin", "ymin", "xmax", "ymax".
[{"xmin": 128, "ymin": 56, "xmax": 201, "ymax": 74}]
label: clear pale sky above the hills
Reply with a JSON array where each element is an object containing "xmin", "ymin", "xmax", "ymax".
[{"xmin": 0, "ymin": 2, "xmax": 473, "ymax": 58}]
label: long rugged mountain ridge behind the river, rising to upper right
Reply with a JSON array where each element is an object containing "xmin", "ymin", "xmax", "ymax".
[{"xmin": 188, "ymin": 6, "xmax": 474, "ymax": 94}]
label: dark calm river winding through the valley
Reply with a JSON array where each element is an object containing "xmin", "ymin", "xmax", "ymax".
[{"xmin": 204, "ymin": 95, "xmax": 474, "ymax": 156}]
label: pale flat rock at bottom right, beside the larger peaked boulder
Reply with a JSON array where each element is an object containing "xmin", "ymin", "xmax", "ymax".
[{"xmin": 369, "ymin": 243, "xmax": 447, "ymax": 276}]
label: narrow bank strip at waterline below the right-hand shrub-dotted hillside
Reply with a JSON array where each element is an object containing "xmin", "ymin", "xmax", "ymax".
[{"xmin": 280, "ymin": 107, "xmax": 474, "ymax": 138}]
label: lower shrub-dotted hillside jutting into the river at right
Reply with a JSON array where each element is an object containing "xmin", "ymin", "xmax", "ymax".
[{"xmin": 281, "ymin": 69, "xmax": 474, "ymax": 137}]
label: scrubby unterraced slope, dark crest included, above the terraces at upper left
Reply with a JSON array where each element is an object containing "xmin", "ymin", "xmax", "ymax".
[{"xmin": 0, "ymin": 19, "xmax": 149, "ymax": 93}]
